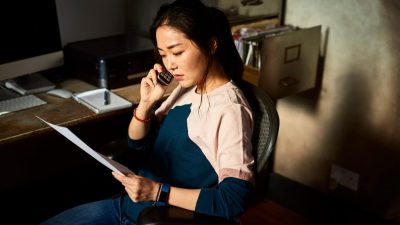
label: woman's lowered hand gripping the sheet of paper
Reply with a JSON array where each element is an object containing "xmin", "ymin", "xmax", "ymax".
[{"xmin": 112, "ymin": 172, "xmax": 161, "ymax": 202}]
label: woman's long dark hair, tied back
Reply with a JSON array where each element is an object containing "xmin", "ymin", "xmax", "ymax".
[{"xmin": 150, "ymin": 0, "xmax": 243, "ymax": 90}]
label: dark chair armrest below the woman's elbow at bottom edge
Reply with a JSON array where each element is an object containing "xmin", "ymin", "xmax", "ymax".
[{"xmin": 137, "ymin": 206, "xmax": 238, "ymax": 225}]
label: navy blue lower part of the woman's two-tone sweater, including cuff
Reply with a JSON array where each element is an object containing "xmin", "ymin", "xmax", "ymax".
[{"xmin": 123, "ymin": 104, "xmax": 252, "ymax": 221}]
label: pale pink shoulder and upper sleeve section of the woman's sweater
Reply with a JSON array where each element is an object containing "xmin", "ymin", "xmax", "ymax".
[{"xmin": 188, "ymin": 100, "xmax": 254, "ymax": 185}]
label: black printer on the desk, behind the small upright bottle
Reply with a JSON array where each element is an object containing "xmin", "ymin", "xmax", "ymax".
[{"xmin": 64, "ymin": 34, "xmax": 155, "ymax": 89}]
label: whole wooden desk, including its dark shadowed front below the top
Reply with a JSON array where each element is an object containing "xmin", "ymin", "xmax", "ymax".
[{"xmin": 0, "ymin": 80, "xmax": 176, "ymax": 192}]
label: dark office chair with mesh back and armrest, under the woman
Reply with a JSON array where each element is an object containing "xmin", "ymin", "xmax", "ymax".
[{"xmin": 137, "ymin": 82, "xmax": 279, "ymax": 225}]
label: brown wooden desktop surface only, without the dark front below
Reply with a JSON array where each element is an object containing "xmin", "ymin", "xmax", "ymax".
[{"xmin": 0, "ymin": 80, "xmax": 175, "ymax": 143}]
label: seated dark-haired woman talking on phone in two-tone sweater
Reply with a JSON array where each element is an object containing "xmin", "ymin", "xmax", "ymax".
[{"xmin": 40, "ymin": 0, "xmax": 254, "ymax": 225}]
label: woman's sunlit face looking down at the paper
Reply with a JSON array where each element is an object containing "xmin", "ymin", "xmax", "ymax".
[{"xmin": 156, "ymin": 25, "xmax": 208, "ymax": 87}]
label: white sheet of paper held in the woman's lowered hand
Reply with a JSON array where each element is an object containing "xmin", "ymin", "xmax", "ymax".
[{"xmin": 36, "ymin": 116, "xmax": 134, "ymax": 175}]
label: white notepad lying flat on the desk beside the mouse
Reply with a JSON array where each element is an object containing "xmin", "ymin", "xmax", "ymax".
[{"xmin": 73, "ymin": 88, "xmax": 132, "ymax": 113}]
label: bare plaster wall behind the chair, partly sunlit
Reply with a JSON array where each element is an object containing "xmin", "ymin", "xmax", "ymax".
[{"xmin": 274, "ymin": 0, "xmax": 400, "ymax": 223}]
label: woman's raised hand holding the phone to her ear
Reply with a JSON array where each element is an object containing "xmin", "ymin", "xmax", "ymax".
[{"xmin": 140, "ymin": 64, "xmax": 167, "ymax": 105}]
